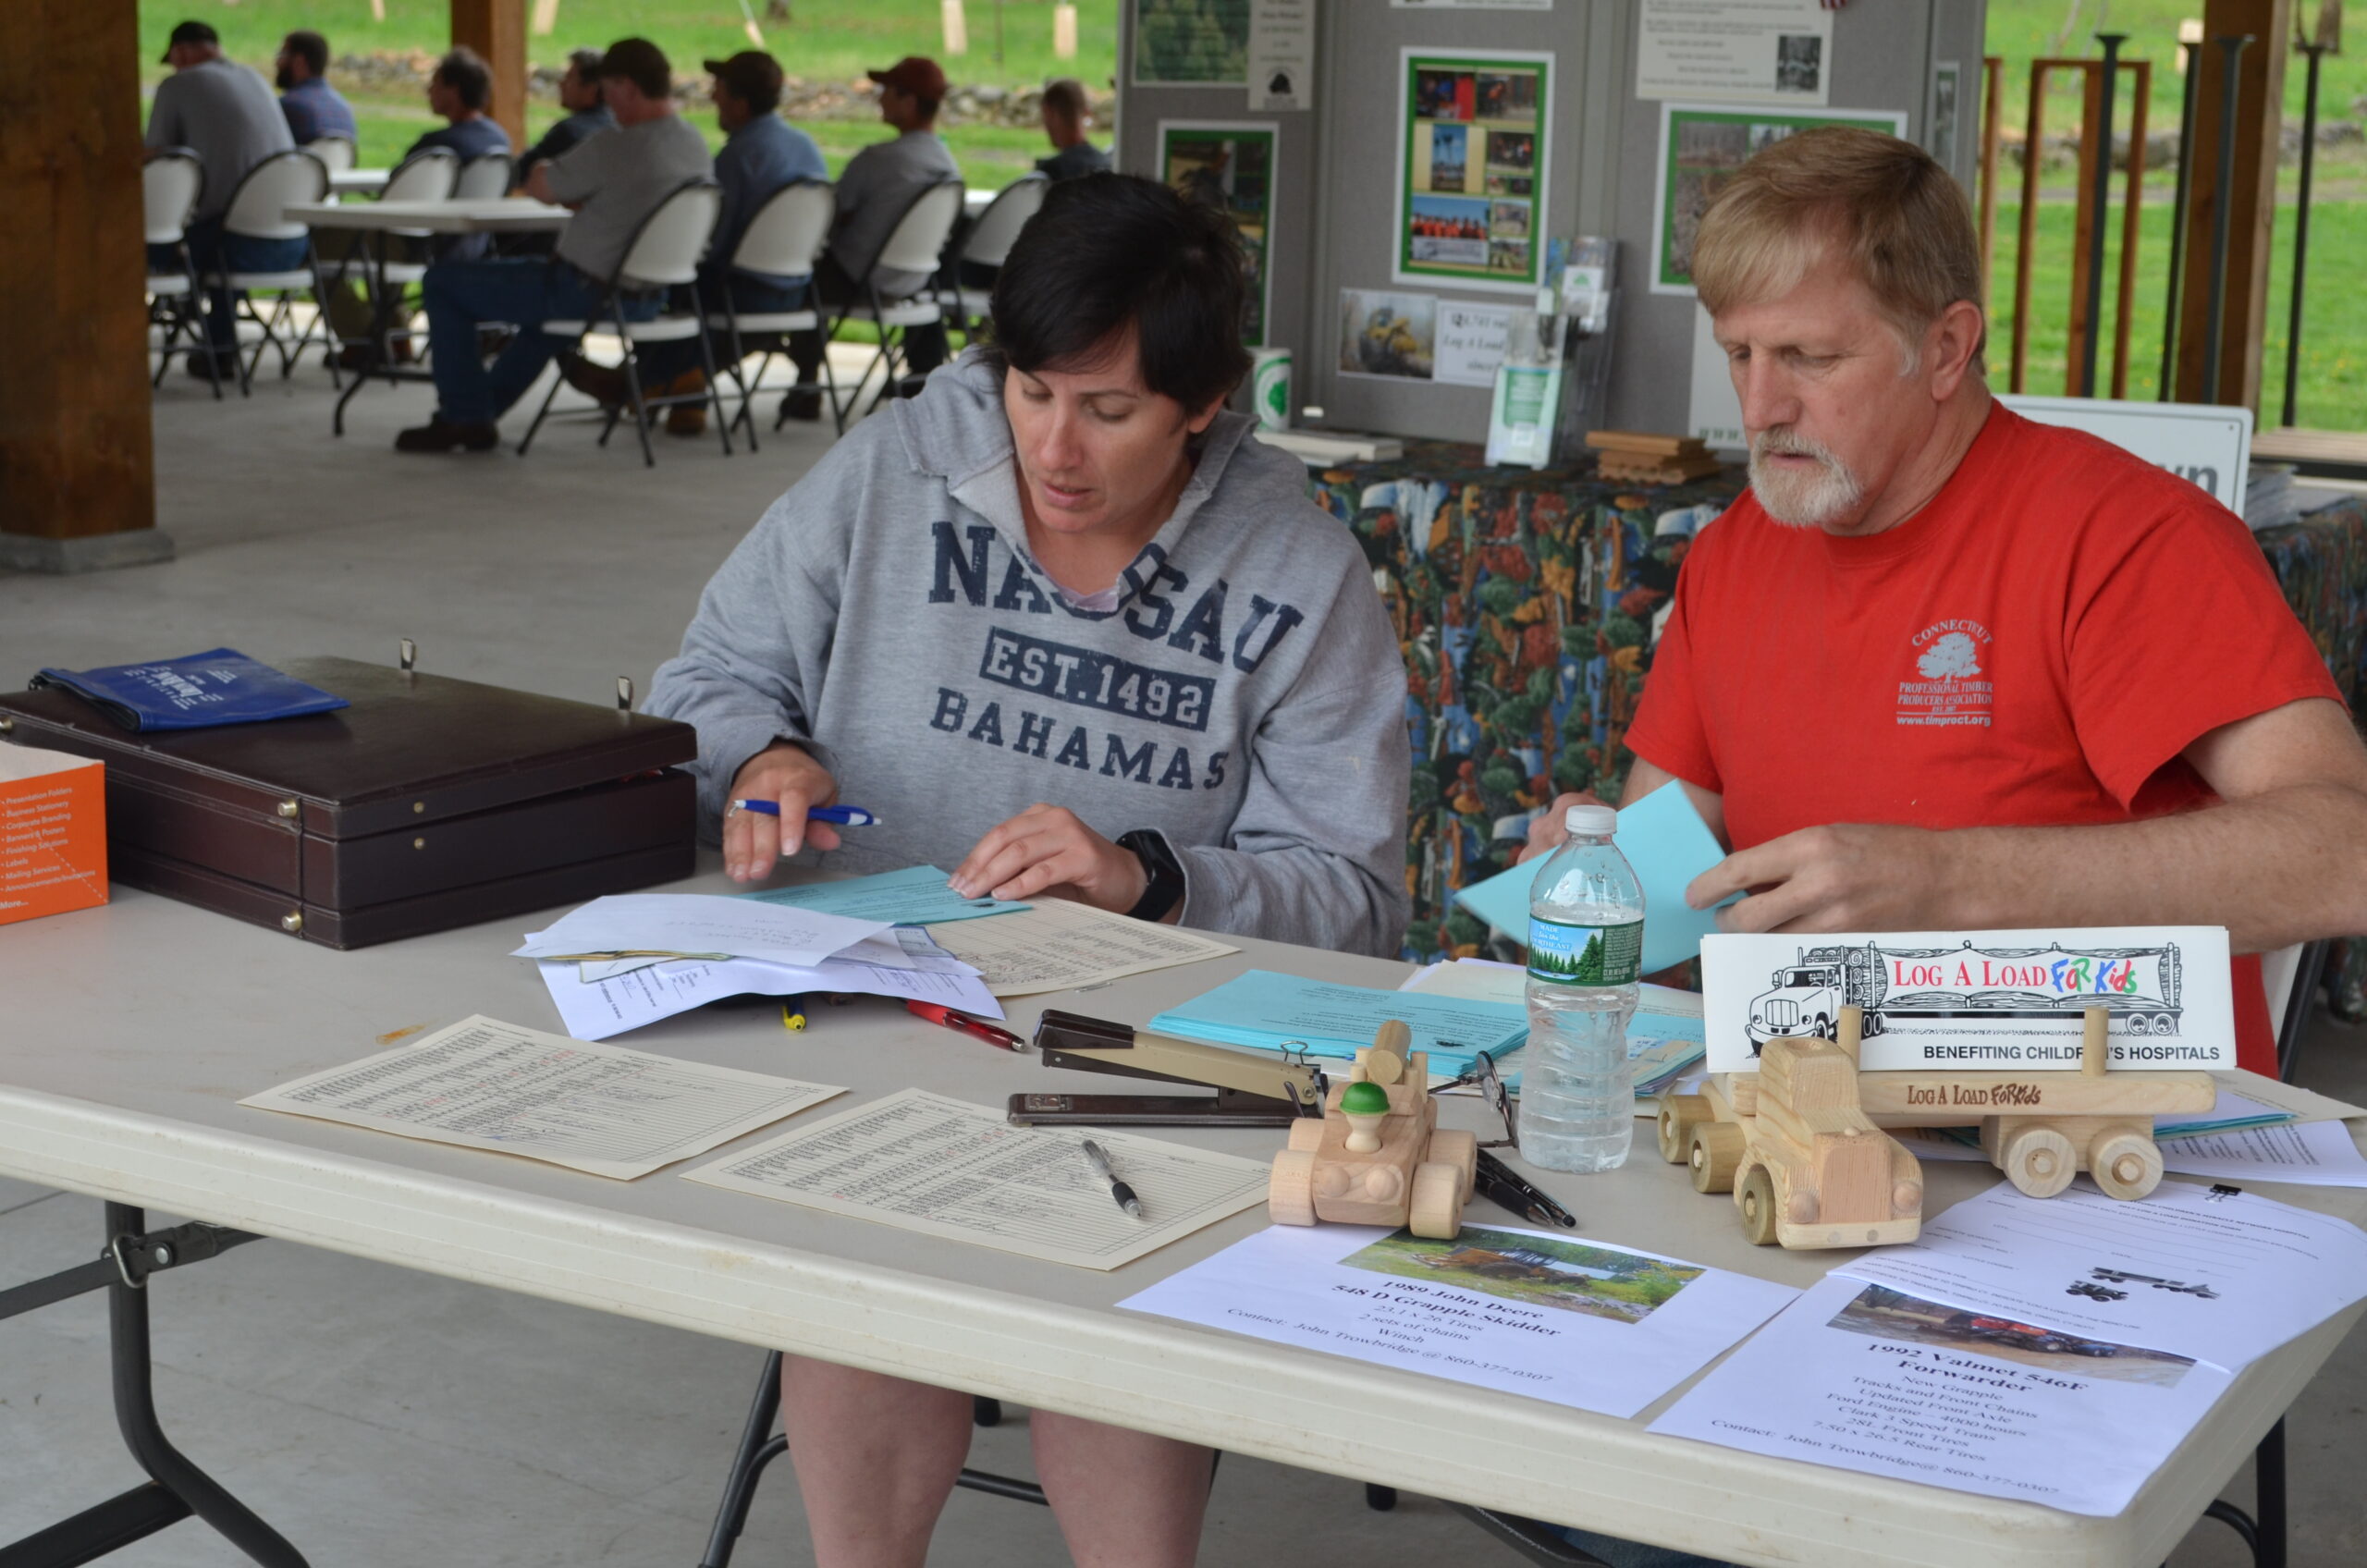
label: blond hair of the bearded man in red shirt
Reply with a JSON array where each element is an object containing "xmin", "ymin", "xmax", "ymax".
[{"xmin": 1692, "ymin": 126, "xmax": 1988, "ymax": 374}]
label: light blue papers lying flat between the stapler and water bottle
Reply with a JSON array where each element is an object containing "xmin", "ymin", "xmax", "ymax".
[{"xmin": 1148, "ymin": 969, "xmax": 1529, "ymax": 1073}]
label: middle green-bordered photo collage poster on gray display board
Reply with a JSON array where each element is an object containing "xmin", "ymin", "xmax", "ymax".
[{"xmin": 1390, "ymin": 50, "xmax": 1552, "ymax": 294}]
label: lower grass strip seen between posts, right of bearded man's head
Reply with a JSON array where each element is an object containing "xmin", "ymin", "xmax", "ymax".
[{"xmin": 1988, "ymin": 202, "xmax": 2367, "ymax": 431}]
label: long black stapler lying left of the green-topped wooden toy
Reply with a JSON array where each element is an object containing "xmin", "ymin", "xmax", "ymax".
[{"xmin": 1011, "ymin": 1011, "xmax": 1331, "ymax": 1127}]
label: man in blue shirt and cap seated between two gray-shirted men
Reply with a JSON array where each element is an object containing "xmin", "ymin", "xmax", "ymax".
[{"xmin": 586, "ymin": 50, "xmax": 831, "ymax": 435}]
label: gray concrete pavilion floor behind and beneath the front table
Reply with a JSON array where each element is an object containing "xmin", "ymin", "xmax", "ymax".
[{"xmin": 0, "ymin": 372, "xmax": 2367, "ymax": 1568}]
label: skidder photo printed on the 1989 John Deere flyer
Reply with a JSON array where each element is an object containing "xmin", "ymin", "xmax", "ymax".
[{"xmin": 1340, "ymin": 1225, "xmax": 1702, "ymax": 1324}]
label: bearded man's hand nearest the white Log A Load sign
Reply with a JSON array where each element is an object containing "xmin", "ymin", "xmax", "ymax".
[{"xmin": 1686, "ymin": 825, "xmax": 1981, "ymax": 931}]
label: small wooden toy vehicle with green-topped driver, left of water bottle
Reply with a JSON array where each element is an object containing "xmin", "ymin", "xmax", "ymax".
[{"xmin": 1267, "ymin": 1019, "xmax": 1479, "ymax": 1241}]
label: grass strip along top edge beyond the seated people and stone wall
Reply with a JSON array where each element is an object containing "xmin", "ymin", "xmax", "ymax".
[{"xmin": 140, "ymin": 0, "xmax": 1117, "ymax": 88}]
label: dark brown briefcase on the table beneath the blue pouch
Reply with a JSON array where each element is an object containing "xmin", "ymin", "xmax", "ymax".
[{"xmin": 0, "ymin": 658, "xmax": 698, "ymax": 948}]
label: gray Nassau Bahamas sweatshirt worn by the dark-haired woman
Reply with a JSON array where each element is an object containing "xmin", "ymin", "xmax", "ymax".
[{"xmin": 648, "ymin": 350, "xmax": 1408, "ymax": 954}]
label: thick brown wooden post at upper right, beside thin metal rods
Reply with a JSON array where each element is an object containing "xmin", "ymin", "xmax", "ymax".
[{"xmin": 2177, "ymin": 0, "xmax": 2294, "ymax": 408}]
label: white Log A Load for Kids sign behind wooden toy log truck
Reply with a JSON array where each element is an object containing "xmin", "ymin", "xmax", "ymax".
[{"xmin": 1702, "ymin": 926, "xmax": 2235, "ymax": 1073}]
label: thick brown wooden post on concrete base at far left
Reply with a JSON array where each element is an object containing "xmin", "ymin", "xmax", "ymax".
[{"xmin": 0, "ymin": 0, "xmax": 172, "ymax": 570}]
